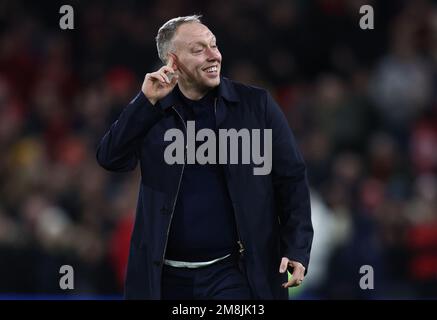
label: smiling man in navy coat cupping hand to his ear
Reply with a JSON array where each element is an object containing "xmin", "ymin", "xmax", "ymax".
[{"xmin": 97, "ymin": 16, "xmax": 313, "ymax": 299}]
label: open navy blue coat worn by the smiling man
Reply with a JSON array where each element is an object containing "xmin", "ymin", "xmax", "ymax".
[{"xmin": 97, "ymin": 78, "xmax": 313, "ymax": 299}]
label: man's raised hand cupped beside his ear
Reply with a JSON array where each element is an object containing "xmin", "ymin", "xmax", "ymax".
[{"xmin": 141, "ymin": 56, "xmax": 178, "ymax": 105}]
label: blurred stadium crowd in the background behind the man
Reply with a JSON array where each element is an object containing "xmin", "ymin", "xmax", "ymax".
[{"xmin": 0, "ymin": 0, "xmax": 437, "ymax": 299}]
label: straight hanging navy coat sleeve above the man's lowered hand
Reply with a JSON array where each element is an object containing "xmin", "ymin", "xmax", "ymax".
[{"xmin": 266, "ymin": 92, "xmax": 314, "ymax": 270}]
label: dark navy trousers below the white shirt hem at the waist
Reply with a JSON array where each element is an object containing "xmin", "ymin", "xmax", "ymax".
[{"xmin": 162, "ymin": 256, "xmax": 252, "ymax": 300}]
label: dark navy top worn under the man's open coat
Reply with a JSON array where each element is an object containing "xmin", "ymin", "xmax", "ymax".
[{"xmin": 166, "ymin": 90, "xmax": 238, "ymax": 262}]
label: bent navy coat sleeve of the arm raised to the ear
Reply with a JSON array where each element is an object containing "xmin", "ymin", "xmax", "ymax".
[{"xmin": 96, "ymin": 92, "xmax": 163, "ymax": 172}]
